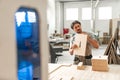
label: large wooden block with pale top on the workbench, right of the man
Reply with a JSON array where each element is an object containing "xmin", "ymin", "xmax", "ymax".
[{"xmin": 92, "ymin": 56, "xmax": 109, "ymax": 71}]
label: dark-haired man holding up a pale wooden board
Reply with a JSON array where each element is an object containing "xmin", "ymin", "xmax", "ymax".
[{"xmin": 69, "ymin": 21, "xmax": 99, "ymax": 65}]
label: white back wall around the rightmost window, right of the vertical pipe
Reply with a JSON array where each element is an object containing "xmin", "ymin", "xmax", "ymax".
[{"xmin": 95, "ymin": 0, "xmax": 120, "ymax": 36}]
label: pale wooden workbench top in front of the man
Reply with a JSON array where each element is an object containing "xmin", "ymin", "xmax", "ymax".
[{"xmin": 48, "ymin": 64, "xmax": 120, "ymax": 80}]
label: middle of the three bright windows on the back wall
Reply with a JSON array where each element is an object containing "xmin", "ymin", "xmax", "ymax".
[{"xmin": 82, "ymin": 8, "xmax": 91, "ymax": 20}]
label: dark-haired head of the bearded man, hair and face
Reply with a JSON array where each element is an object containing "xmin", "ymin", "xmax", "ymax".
[{"xmin": 71, "ymin": 20, "xmax": 82, "ymax": 33}]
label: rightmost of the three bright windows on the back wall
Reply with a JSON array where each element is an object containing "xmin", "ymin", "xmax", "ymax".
[{"xmin": 98, "ymin": 7, "xmax": 112, "ymax": 20}]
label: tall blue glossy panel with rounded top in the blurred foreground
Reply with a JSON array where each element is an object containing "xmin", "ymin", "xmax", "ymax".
[{"xmin": 15, "ymin": 7, "xmax": 40, "ymax": 80}]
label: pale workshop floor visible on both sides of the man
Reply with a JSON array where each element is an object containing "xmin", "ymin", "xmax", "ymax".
[{"xmin": 57, "ymin": 45, "xmax": 107, "ymax": 64}]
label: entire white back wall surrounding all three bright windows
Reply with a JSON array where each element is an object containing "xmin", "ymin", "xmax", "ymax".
[{"xmin": 59, "ymin": 0, "xmax": 120, "ymax": 36}]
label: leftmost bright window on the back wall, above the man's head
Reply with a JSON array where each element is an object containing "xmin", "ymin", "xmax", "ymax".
[{"xmin": 66, "ymin": 8, "xmax": 78, "ymax": 20}]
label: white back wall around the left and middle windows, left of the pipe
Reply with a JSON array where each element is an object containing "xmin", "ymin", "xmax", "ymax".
[{"xmin": 64, "ymin": 2, "xmax": 91, "ymax": 32}]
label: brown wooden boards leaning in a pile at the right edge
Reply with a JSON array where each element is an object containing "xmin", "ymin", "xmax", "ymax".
[{"xmin": 104, "ymin": 21, "xmax": 120, "ymax": 64}]
